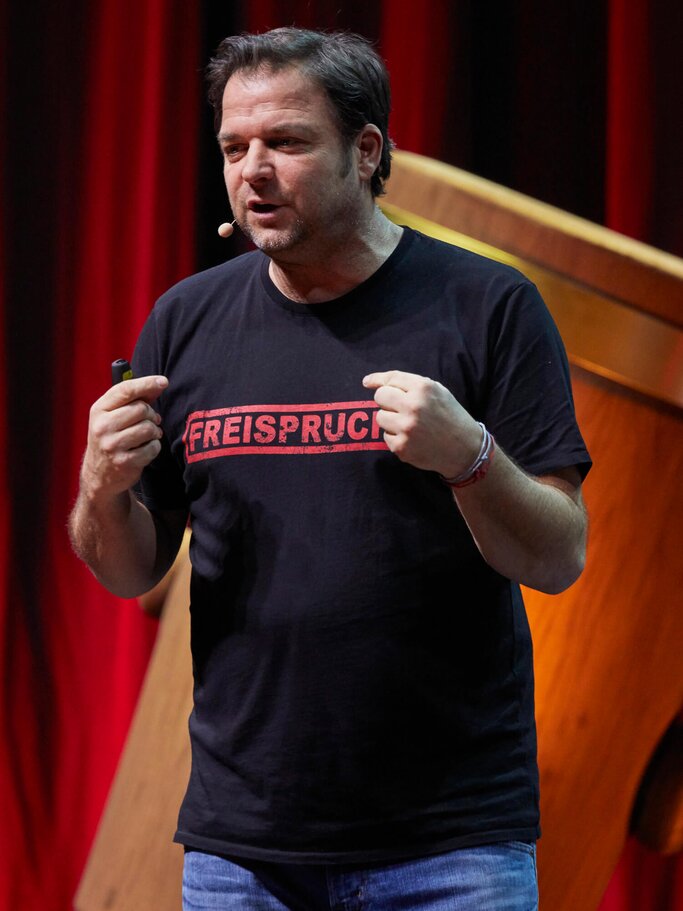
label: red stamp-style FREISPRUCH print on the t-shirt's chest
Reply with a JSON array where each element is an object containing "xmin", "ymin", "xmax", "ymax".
[{"xmin": 183, "ymin": 401, "xmax": 387, "ymax": 462}]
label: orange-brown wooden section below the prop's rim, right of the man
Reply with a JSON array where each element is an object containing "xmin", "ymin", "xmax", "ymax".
[{"xmin": 525, "ymin": 371, "xmax": 683, "ymax": 911}]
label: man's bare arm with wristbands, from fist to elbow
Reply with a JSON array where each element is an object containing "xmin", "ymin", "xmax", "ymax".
[{"xmin": 363, "ymin": 370, "xmax": 587, "ymax": 594}]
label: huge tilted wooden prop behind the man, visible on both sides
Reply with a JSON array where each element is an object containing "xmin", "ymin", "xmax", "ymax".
[{"xmin": 75, "ymin": 152, "xmax": 683, "ymax": 911}]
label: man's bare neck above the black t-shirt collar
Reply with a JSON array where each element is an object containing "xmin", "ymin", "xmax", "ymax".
[{"xmin": 269, "ymin": 206, "xmax": 403, "ymax": 304}]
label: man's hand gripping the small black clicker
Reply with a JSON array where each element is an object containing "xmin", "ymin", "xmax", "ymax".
[{"xmin": 81, "ymin": 376, "xmax": 168, "ymax": 497}]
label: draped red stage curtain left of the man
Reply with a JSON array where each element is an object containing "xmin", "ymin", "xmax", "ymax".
[{"xmin": 0, "ymin": 0, "xmax": 200, "ymax": 911}]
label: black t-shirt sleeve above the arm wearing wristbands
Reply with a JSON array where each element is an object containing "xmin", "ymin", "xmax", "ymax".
[{"xmin": 483, "ymin": 281, "xmax": 591, "ymax": 478}]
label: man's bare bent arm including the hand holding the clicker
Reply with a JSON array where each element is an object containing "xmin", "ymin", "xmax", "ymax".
[{"xmin": 69, "ymin": 376, "xmax": 187, "ymax": 598}]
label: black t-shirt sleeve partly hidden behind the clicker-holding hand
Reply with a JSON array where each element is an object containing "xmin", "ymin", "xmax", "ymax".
[{"xmin": 131, "ymin": 311, "xmax": 188, "ymax": 511}]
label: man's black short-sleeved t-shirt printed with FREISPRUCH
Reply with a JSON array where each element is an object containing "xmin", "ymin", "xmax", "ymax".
[{"xmin": 134, "ymin": 229, "xmax": 590, "ymax": 863}]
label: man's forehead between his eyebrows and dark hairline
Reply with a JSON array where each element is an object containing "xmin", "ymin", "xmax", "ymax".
[{"xmin": 221, "ymin": 67, "xmax": 337, "ymax": 132}]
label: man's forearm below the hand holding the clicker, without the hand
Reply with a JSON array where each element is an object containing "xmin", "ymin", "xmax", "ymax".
[{"xmin": 69, "ymin": 489, "xmax": 173, "ymax": 598}]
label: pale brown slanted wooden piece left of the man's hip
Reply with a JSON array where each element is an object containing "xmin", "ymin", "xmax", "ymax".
[{"xmin": 74, "ymin": 547, "xmax": 192, "ymax": 911}]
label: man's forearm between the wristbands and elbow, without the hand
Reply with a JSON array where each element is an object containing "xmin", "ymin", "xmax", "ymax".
[{"xmin": 453, "ymin": 449, "xmax": 587, "ymax": 594}]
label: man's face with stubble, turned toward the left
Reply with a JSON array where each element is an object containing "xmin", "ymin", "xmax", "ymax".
[{"xmin": 218, "ymin": 68, "xmax": 368, "ymax": 262}]
